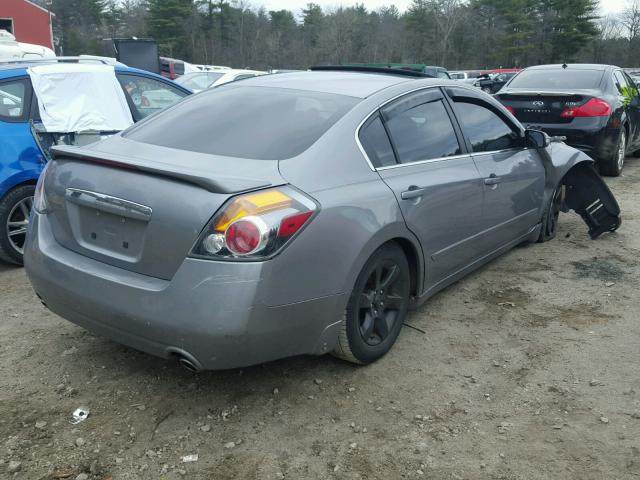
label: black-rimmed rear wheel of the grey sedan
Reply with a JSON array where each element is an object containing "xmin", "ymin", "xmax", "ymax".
[{"xmin": 333, "ymin": 243, "xmax": 410, "ymax": 365}]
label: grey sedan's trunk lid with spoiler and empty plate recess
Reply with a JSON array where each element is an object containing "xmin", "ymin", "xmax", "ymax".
[{"xmin": 44, "ymin": 139, "xmax": 285, "ymax": 280}]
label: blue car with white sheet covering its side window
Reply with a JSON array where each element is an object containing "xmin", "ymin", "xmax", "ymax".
[{"xmin": 0, "ymin": 58, "xmax": 192, "ymax": 265}]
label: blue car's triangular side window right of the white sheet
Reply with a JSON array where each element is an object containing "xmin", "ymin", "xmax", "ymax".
[{"xmin": 117, "ymin": 73, "xmax": 187, "ymax": 120}]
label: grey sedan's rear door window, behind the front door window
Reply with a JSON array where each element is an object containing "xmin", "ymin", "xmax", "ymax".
[{"xmin": 387, "ymin": 99, "xmax": 461, "ymax": 163}]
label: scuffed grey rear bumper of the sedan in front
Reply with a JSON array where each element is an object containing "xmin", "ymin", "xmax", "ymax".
[{"xmin": 25, "ymin": 212, "xmax": 347, "ymax": 369}]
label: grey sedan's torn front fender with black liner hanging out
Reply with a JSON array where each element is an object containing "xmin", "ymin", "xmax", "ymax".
[{"xmin": 540, "ymin": 141, "xmax": 622, "ymax": 239}]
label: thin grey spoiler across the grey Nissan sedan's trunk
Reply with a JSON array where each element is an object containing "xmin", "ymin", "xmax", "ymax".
[{"xmin": 51, "ymin": 145, "xmax": 272, "ymax": 194}]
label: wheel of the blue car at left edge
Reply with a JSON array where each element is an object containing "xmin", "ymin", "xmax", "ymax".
[{"xmin": 0, "ymin": 185, "xmax": 35, "ymax": 265}]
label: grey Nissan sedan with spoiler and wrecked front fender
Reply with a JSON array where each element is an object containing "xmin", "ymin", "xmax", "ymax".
[{"xmin": 25, "ymin": 68, "xmax": 620, "ymax": 370}]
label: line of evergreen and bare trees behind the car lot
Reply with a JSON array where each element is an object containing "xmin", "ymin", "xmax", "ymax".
[{"xmin": 33, "ymin": 0, "xmax": 640, "ymax": 70}]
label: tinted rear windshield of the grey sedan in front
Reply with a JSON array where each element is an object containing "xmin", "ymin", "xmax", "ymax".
[{"xmin": 124, "ymin": 85, "xmax": 360, "ymax": 160}]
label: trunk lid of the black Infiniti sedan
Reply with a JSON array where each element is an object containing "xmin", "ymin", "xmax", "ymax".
[{"xmin": 496, "ymin": 90, "xmax": 597, "ymax": 126}]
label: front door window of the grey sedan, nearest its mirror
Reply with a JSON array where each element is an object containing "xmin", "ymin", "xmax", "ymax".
[{"xmin": 454, "ymin": 100, "xmax": 523, "ymax": 152}]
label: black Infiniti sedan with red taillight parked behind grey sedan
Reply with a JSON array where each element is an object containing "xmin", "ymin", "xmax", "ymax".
[{"xmin": 496, "ymin": 64, "xmax": 640, "ymax": 176}]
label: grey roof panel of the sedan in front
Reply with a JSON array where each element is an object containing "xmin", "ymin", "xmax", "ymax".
[{"xmin": 242, "ymin": 71, "xmax": 438, "ymax": 98}]
